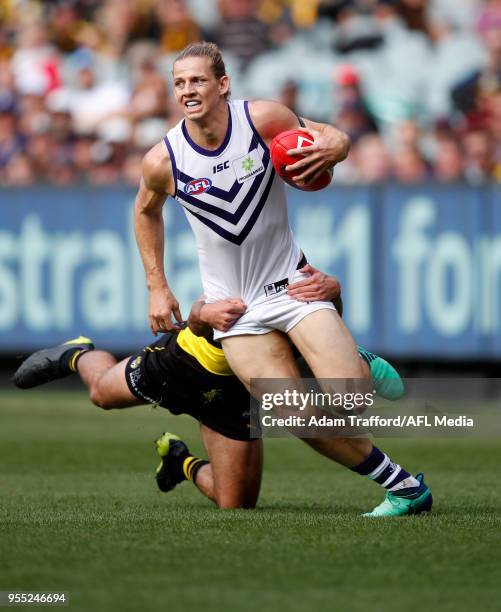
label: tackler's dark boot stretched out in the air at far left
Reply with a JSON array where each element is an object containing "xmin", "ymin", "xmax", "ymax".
[{"xmin": 13, "ymin": 336, "xmax": 94, "ymax": 389}]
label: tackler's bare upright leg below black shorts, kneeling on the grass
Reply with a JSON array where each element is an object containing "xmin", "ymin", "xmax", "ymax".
[{"xmin": 201, "ymin": 425, "xmax": 263, "ymax": 508}]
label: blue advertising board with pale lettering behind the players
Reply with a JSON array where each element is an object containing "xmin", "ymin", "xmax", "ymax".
[{"xmin": 0, "ymin": 185, "xmax": 501, "ymax": 359}]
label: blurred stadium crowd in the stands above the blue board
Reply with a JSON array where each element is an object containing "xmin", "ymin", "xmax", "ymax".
[{"xmin": 0, "ymin": 0, "xmax": 501, "ymax": 186}]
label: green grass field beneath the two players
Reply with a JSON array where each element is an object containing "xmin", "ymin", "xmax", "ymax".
[{"xmin": 0, "ymin": 389, "xmax": 501, "ymax": 612}]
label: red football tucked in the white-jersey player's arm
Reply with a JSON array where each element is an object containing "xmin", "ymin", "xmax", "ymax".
[{"xmin": 270, "ymin": 130, "xmax": 332, "ymax": 191}]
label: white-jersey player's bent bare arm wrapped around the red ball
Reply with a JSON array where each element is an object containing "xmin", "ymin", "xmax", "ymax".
[{"xmin": 249, "ymin": 100, "xmax": 350, "ymax": 186}]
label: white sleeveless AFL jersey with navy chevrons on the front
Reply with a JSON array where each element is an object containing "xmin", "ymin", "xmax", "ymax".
[{"xmin": 165, "ymin": 100, "xmax": 300, "ymax": 308}]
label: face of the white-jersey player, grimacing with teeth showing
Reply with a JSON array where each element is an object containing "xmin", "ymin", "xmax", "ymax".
[{"xmin": 173, "ymin": 57, "xmax": 229, "ymax": 120}]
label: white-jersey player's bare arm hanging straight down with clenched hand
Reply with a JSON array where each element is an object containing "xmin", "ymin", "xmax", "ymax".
[{"xmin": 134, "ymin": 142, "xmax": 182, "ymax": 335}]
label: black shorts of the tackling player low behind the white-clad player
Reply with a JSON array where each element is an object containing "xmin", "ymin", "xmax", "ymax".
[{"xmin": 125, "ymin": 333, "xmax": 250, "ymax": 440}]
